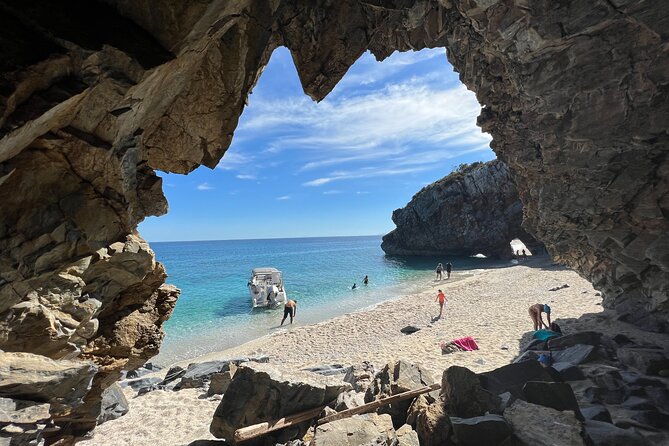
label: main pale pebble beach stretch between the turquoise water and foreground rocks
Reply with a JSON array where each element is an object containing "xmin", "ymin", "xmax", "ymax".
[{"xmin": 168, "ymin": 256, "xmax": 602, "ymax": 378}]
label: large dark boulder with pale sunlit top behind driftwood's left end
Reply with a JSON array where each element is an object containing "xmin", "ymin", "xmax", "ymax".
[{"xmin": 210, "ymin": 362, "xmax": 351, "ymax": 442}]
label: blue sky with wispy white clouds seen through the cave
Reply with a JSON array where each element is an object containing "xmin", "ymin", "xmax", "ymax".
[{"xmin": 139, "ymin": 48, "xmax": 495, "ymax": 241}]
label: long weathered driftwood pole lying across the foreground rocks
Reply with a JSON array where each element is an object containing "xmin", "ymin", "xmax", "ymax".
[{"xmin": 234, "ymin": 384, "xmax": 441, "ymax": 443}]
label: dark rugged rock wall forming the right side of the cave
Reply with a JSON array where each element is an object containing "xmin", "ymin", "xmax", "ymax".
[{"xmin": 448, "ymin": 0, "xmax": 669, "ymax": 331}]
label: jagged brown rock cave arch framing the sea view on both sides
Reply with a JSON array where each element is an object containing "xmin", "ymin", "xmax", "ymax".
[{"xmin": 0, "ymin": 0, "xmax": 669, "ymax": 440}]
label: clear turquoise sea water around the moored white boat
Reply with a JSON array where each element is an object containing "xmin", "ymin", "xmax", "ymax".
[{"xmin": 151, "ymin": 236, "xmax": 500, "ymax": 364}]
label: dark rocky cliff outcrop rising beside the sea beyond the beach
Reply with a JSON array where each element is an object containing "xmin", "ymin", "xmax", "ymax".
[{"xmin": 381, "ymin": 161, "xmax": 539, "ymax": 258}]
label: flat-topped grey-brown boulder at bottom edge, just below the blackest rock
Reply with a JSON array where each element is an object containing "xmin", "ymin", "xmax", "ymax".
[{"xmin": 504, "ymin": 400, "xmax": 585, "ymax": 446}]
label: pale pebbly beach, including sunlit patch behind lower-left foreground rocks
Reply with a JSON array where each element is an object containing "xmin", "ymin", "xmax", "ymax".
[{"xmin": 80, "ymin": 257, "xmax": 656, "ymax": 445}]
